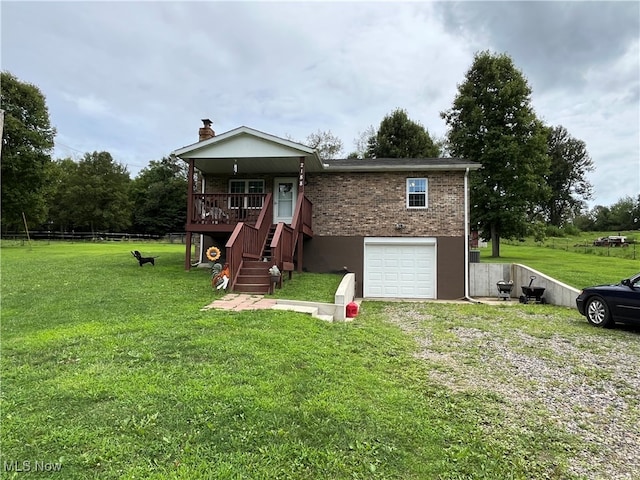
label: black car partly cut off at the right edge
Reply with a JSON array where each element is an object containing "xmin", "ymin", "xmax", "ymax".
[{"xmin": 576, "ymin": 273, "xmax": 640, "ymax": 327}]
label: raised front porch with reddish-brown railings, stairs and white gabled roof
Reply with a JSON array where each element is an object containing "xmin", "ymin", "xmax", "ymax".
[{"xmin": 173, "ymin": 124, "xmax": 323, "ymax": 293}]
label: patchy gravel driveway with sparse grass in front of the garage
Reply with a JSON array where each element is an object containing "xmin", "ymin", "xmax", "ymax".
[{"xmin": 385, "ymin": 303, "xmax": 640, "ymax": 480}]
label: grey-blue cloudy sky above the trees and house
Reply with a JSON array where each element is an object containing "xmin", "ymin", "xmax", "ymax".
[{"xmin": 0, "ymin": 1, "xmax": 640, "ymax": 206}]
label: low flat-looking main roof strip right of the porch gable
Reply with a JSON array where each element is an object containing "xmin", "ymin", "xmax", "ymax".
[{"xmin": 324, "ymin": 158, "xmax": 481, "ymax": 172}]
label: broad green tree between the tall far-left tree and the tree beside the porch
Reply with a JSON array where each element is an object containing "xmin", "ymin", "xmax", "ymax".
[{"xmin": 52, "ymin": 152, "xmax": 133, "ymax": 231}]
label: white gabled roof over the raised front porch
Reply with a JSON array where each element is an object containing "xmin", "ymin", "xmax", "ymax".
[{"xmin": 172, "ymin": 126, "xmax": 323, "ymax": 174}]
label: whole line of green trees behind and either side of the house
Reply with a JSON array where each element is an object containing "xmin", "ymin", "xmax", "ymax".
[{"xmin": 1, "ymin": 51, "xmax": 640, "ymax": 256}]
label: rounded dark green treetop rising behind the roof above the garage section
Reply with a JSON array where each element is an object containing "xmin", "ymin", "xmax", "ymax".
[{"xmin": 367, "ymin": 108, "xmax": 440, "ymax": 158}]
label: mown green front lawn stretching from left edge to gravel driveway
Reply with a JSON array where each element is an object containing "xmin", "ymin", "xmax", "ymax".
[{"xmin": 0, "ymin": 243, "xmax": 636, "ymax": 479}]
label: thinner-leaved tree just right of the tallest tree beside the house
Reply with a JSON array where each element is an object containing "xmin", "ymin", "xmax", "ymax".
[{"xmin": 542, "ymin": 126, "xmax": 594, "ymax": 227}]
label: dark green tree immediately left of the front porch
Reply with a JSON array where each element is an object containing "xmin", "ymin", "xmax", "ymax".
[{"xmin": 131, "ymin": 157, "xmax": 188, "ymax": 235}]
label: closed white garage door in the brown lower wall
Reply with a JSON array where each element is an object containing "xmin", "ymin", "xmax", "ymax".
[{"xmin": 363, "ymin": 237, "xmax": 436, "ymax": 298}]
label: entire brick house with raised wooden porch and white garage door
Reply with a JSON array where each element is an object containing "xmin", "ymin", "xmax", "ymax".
[{"xmin": 173, "ymin": 120, "xmax": 480, "ymax": 299}]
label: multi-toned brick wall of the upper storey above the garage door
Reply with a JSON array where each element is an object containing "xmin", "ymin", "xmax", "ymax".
[{"xmin": 305, "ymin": 172, "xmax": 464, "ymax": 237}]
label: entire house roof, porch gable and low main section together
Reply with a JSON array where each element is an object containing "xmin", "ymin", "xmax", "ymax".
[{"xmin": 172, "ymin": 126, "xmax": 481, "ymax": 174}]
